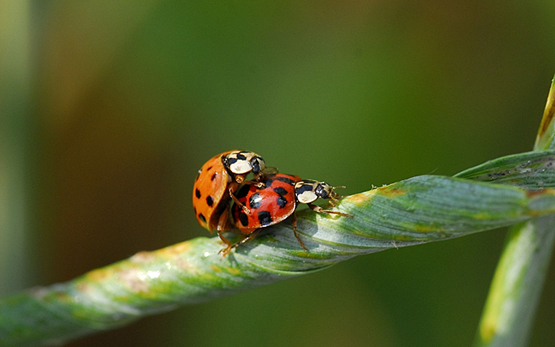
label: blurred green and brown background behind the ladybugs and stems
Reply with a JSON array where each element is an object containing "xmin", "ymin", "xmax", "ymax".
[{"xmin": 0, "ymin": 0, "xmax": 555, "ymax": 347}]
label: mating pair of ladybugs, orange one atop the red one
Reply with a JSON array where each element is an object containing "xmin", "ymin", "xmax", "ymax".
[{"xmin": 193, "ymin": 150, "xmax": 351, "ymax": 256}]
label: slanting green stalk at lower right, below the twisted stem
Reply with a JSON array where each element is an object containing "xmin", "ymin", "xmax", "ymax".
[{"xmin": 476, "ymin": 216, "xmax": 555, "ymax": 347}]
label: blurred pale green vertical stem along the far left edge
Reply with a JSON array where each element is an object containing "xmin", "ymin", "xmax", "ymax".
[{"xmin": 0, "ymin": 0, "xmax": 37, "ymax": 293}]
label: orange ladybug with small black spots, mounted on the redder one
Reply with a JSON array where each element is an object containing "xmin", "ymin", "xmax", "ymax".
[{"xmin": 193, "ymin": 149, "xmax": 266, "ymax": 246}]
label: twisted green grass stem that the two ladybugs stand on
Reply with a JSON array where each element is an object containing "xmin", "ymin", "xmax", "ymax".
[{"xmin": 0, "ymin": 170, "xmax": 555, "ymax": 345}]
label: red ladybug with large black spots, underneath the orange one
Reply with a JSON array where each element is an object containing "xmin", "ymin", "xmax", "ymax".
[{"xmin": 222, "ymin": 174, "xmax": 352, "ymax": 256}]
